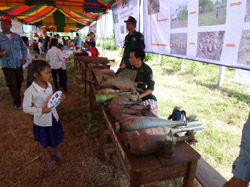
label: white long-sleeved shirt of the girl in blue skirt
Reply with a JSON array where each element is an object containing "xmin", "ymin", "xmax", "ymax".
[{"xmin": 23, "ymin": 81, "xmax": 59, "ymax": 127}]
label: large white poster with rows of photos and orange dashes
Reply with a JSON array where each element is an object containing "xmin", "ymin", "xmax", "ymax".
[{"xmin": 143, "ymin": 0, "xmax": 250, "ymax": 70}]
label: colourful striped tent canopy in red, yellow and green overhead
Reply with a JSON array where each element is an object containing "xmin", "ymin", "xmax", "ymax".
[{"xmin": 0, "ymin": 0, "xmax": 114, "ymax": 32}]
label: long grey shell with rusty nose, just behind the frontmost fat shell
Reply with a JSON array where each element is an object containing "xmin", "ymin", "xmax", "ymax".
[{"xmin": 115, "ymin": 116, "xmax": 201, "ymax": 132}]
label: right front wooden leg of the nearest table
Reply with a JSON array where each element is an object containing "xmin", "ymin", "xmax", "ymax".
[{"xmin": 183, "ymin": 160, "xmax": 198, "ymax": 187}]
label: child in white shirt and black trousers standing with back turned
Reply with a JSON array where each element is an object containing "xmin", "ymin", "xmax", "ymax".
[{"xmin": 46, "ymin": 38, "xmax": 64, "ymax": 91}]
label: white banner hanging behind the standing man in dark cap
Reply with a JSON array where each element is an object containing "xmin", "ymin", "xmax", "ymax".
[{"xmin": 111, "ymin": 0, "xmax": 139, "ymax": 47}]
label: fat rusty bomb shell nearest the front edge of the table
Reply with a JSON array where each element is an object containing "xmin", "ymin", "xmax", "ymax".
[{"xmin": 123, "ymin": 127, "xmax": 186, "ymax": 155}]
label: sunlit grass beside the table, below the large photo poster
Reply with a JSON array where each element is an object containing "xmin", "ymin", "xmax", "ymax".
[{"xmin": 148, "ymin": 57, "xmax": 250, "ymax": 179}]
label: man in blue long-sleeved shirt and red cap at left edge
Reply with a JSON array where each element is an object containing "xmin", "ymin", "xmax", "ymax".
[{"xmin": 0, "ymin": 15, "xmax": 27, "ymax": 109}]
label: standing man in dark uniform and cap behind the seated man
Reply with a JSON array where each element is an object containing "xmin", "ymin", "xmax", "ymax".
[{"xmin": 120, "ymin": 16, "xmax": 145, "ymax": 69}]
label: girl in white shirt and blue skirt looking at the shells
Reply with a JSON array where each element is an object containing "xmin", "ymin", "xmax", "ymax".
[{"xmin": 23, "ymin": 60, "xmax": 64, "ymax": 170}]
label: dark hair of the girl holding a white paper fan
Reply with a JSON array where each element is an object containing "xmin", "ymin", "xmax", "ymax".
[{"xmin": 28, "ymin": 60, "xmax": 50, "ymax": 80}]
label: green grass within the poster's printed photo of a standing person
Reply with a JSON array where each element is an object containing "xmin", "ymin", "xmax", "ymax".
[{"xmin": 199, "ymin": 8, "xmax": 226, "ymax": 26}]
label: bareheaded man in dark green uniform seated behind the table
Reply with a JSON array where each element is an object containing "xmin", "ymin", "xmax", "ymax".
[{"xmin": 129, "ymin": 48, "xmax": 158, "ymax": 115}]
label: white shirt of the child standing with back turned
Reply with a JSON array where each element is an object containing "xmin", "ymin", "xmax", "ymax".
[{"xmin": 46, "ymin": 46, "xmax": 63, "ymax": 69}]
